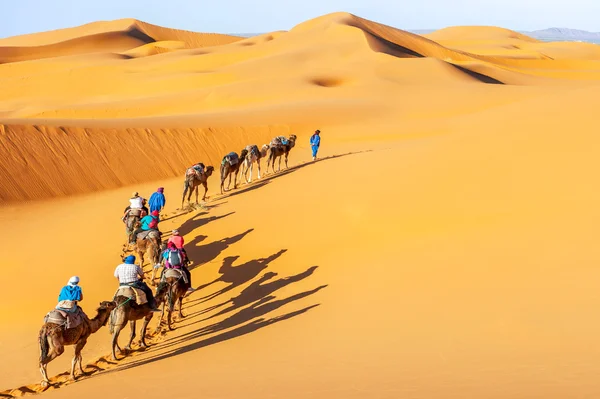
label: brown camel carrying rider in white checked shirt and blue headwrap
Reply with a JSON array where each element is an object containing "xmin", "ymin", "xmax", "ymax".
[{"xmin": 109, "ymin": 290, "xmax": 166, "ymax": 360}]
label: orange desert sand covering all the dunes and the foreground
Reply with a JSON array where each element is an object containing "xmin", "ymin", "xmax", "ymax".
[{"xmin": 0, "ymin": 13, "xmax": 600, "ymax": 399}]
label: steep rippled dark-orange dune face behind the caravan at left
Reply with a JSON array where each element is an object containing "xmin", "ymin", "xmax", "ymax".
[{"xmin": 0, "ymin": 125, "xmax": 289, "ymax": 202}]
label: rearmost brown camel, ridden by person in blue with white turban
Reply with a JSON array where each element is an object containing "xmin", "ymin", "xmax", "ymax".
[{"xmin": 38, "ymin": 301, "xmax": 117, "ymax": 388}]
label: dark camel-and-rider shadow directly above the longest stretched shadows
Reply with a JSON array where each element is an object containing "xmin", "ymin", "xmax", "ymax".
[{"xmin": 188, "ymin": 249, "xmax": 287, "ymax": 306}]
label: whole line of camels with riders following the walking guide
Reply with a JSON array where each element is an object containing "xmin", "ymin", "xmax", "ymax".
[{"xmin": 38, "ymin": 134, "xmax": 296, "ymax": 387}]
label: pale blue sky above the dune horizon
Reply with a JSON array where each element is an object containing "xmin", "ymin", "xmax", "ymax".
[{"xmin": 0, "ymin": 0, "xmax": 600, "ymax": 37}]
